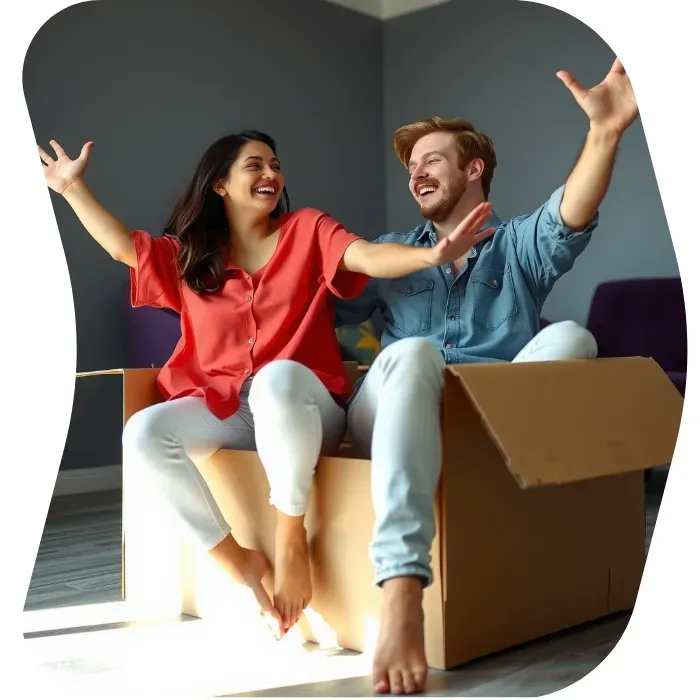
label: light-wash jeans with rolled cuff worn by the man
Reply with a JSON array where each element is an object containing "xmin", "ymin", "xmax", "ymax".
[{"xmin": 348, "ymin": 321, "xmax": 598, "ymax": 585}]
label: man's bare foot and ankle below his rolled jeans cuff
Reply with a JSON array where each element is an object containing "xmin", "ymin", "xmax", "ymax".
[{"xmin": 372, "ymin": 576, "xmax": 428, "ymax": 695}]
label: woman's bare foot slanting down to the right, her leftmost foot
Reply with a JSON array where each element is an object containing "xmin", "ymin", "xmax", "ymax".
[{"xmin": 209, "ymin": 535, "xmax": 284, "ymax": 639}]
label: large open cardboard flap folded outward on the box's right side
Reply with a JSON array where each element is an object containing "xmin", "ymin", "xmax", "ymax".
[{"xmin": 447, "ymin": 357, "xmax": 683, "ymax": 488}]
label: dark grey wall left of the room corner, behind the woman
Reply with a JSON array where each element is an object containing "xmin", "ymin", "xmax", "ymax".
[{"xmin": 24, "ymin": 0, "xmax": 385, "ymax": 468}]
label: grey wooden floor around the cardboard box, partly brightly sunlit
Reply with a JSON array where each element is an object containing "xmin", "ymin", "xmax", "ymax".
[{"xmin": 25, "ymin": 472, "xmax": 664, "ymax": 697}]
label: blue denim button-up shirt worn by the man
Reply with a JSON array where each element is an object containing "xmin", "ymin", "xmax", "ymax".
[{"xmin": 335, "ymin": 185, "xmax": 599, "ymax": 364}]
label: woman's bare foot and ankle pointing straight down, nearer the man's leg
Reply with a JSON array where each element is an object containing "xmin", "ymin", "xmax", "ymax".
[{"xmin": 274, "ymin": 513, "xmax": 312, "ymax": 632}]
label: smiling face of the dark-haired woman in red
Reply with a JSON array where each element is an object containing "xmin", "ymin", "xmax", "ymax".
[{"xmin": 215, "ymin": 141, "xmax": 284, "ymax": 214}]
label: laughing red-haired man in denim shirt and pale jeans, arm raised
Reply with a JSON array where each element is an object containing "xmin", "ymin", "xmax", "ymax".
[{"xmin": 337, "ymin": 60, "xmax": 638, "ymax": 694}]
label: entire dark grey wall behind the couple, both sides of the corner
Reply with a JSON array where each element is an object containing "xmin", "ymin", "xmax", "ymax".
[{"xmin": 24, "ymin": 0, "xmax": 677, "ymax": 476}]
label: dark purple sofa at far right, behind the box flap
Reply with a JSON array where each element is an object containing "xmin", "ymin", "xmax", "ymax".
[{"xmin": 586, "ymin": 277, "xmax": 688, "ymax": 396}]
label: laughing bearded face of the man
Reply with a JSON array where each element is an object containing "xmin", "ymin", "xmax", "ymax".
[{"xmin": 408, "ymin": 131, "xmax": 469, "ymax": 223}]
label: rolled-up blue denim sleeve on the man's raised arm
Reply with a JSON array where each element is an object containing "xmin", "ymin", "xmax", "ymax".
[{"xmin": 507, "ymin": 185, "xmax": 599, "ymax": 300}]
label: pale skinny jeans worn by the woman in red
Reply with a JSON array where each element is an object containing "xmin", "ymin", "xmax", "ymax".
[{"xmin": 123, "ymin": 360, "xmax": 346, "ymax": 550}]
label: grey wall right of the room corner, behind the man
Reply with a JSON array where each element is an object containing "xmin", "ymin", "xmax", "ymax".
[{"xmin": 384, "ymin": 0, "xmax": 678, "ymax": 323}]
